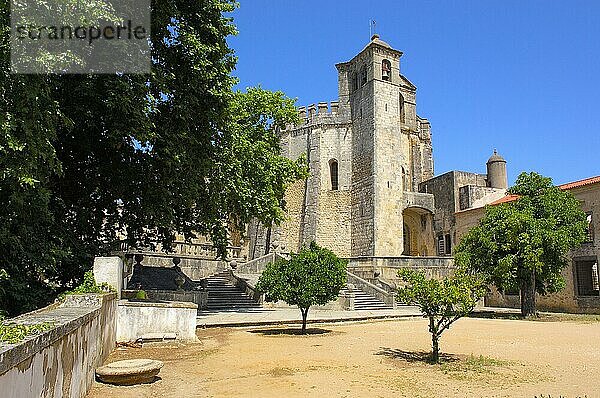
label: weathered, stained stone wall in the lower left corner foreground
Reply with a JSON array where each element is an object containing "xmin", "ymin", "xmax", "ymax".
[{"xmin": 0, "ymin": 293, "xmax": 117, "ymax": 398}]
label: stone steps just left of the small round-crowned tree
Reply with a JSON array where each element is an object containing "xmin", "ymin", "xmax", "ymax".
[{"xmin": 206, "ymin": 273, "xmax": 262, "ymax": 311}]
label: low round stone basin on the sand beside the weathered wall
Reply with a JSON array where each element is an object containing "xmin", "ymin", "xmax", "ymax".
[{"xmin": 96, "ymin": 359, "xmax": 164, "ymax": 386}]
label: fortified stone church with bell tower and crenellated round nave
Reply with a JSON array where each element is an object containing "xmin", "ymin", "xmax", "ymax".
[{"xmin": 248, "ymin": 35, "xmax": 507, "ymax": 259}]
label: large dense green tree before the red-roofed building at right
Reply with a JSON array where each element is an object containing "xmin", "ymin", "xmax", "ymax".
[{"xmin": 455, "ymin": 173, "xmax": 587, "ymax": 316}]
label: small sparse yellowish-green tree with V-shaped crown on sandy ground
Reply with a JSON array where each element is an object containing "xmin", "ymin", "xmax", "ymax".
[{"xmin": 397, "ymin": 269, "xmax": 487, "ymax": 363}]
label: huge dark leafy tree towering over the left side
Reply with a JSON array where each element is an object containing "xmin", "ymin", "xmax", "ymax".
[{"xmin": 0, "ymin": 0, "xmax": 305, "ymax": 314}]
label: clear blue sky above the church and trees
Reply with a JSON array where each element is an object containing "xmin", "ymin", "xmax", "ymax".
[{"xmin": 229, "ymin": 0, "xmax": 600, "ymax": 184}]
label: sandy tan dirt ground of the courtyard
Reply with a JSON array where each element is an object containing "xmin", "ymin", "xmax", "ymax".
[{"xmin": 88, "ymin": 318, "xmax": 600, "ymax": 398}]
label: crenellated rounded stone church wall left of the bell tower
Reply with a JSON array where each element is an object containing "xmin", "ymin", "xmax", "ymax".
[{"xmin": 250, "ymin": 102, "xmax": 352, "ymax": 259}]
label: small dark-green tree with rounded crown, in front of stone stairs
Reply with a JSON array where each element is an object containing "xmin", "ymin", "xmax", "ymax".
[{"xmin": 256, "ymin": 242, "xmax": 347, "ymax": 334}]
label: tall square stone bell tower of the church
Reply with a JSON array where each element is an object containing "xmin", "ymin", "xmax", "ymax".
[{"xmin": 336, "ymin": 35, "xmax": 433, "ymax": 256}]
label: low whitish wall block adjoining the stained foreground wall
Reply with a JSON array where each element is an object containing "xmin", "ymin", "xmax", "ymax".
[{"xmin": 117, "ymin": 300, "xmax": 198, "ymax": 342}]
